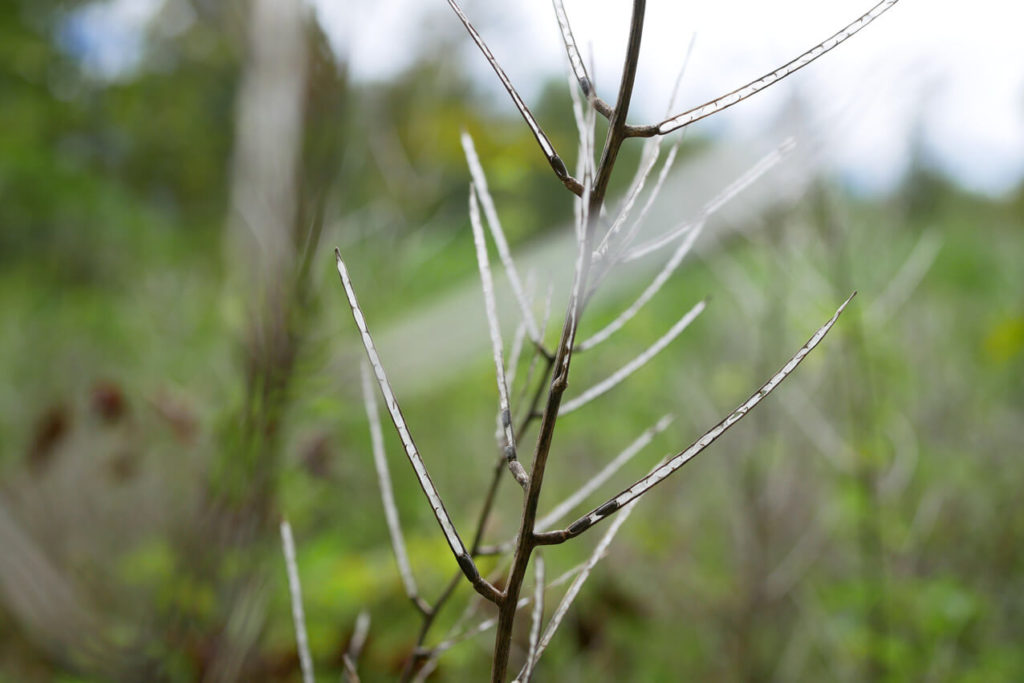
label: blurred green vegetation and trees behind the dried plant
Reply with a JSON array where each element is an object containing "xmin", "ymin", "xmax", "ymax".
[{"xmin": 0, "ymin": 0, "xmax": 1024, "ymax": 681}]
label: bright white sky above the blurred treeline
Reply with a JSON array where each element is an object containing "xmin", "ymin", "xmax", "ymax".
[{"xmin": 311, "ymin": 0, "xmax": 1024, "ymax": 195}]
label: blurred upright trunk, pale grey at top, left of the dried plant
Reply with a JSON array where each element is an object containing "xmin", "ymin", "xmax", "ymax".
[{"xmin": 207, "ymin": 0, "xmax": 309, "ymax": 681}]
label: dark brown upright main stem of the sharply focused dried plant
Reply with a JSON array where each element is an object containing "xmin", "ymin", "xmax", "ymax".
[{"xmin": 490, "ymin": 0, "xmax": 647, "ymax": 683}]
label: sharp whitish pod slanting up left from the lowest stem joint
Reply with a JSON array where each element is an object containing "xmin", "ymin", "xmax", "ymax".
[{"xmin": 334, "ymin": 249, "xmax": 501, "ymax": 602}]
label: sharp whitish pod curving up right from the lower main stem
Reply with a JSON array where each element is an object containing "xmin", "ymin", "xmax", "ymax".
[{"xmin": 535, "ymin": 292, "xmax": 857, "ymax": 545}]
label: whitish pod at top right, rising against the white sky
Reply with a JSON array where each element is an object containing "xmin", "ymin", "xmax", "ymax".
[{"xmin": 628, "ymin": 0, "xmax": 899, "ymax": 137}]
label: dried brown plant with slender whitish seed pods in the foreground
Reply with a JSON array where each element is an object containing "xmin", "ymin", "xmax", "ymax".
[{"xmin": 283, "ymin": 0, "xmax": 897, "ymax": 682}]
